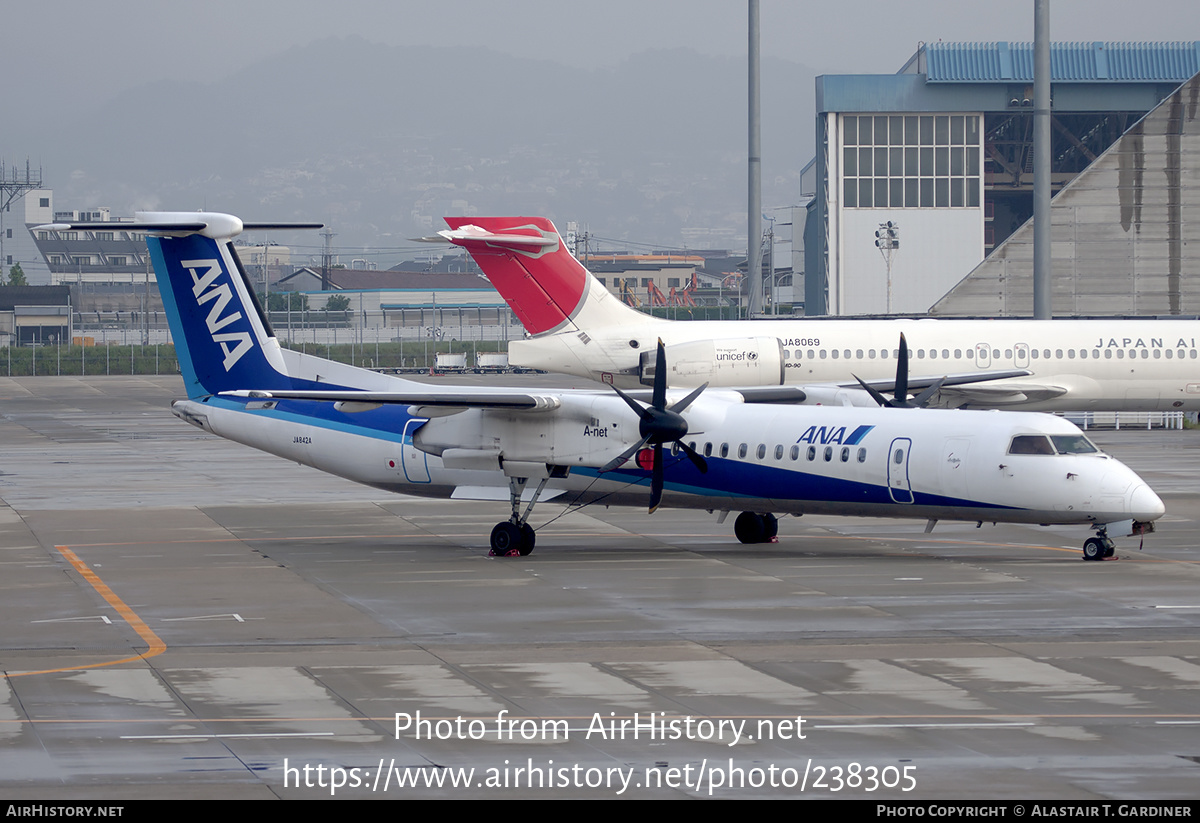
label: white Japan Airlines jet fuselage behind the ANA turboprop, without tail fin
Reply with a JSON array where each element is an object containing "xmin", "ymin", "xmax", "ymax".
[{"xmin": 509, "ymin": 318, "xmax": 1200, "ymax": 412}]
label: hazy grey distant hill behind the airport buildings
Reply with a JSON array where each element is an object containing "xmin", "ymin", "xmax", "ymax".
[{"xmin": 18, "ymin": 37, "xmax": 814, "ymax": 263}]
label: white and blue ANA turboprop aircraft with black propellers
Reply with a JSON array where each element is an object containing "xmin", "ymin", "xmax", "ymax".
[{"xmin": 39, "ymin": 212, "xmax": 1163, "ymax": 559}]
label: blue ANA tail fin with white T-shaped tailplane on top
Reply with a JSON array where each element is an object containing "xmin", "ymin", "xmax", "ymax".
[{"xmin": 42, "ymin": 211, "xmax": 320, "ymax": 398}]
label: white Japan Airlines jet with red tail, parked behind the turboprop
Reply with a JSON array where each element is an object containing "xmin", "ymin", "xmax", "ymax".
[{"xmin": 436, "ymin": 217, "xmax": 1200, "ymax": 412}]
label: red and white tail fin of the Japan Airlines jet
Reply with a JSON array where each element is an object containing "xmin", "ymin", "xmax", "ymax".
[{"xmin": 438, "ymin": 217, "xmax": 646, "ymax": 335}]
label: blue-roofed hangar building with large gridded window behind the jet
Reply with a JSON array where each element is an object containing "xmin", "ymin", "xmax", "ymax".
[{"xmin": 804, "ymin": 42, "xmax": 1200, "ymax": 316}]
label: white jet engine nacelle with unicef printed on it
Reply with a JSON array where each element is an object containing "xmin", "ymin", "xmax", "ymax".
[{"xmin": 641, "ymin": 337, "xmax": 784, "ymax": 388}]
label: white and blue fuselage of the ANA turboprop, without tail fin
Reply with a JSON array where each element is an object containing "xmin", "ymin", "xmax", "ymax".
[{"xmin": 174, "ymin": 390, "xmax": 1162, "ymax": 532}]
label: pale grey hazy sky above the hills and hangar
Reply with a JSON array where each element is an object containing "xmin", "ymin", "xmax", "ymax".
[{"xmin": 9, "ymin": 0, "xmax": 1200, "ymax": 107}]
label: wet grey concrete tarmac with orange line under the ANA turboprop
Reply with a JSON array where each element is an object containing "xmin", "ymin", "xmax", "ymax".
[{"xmin": 0, "ymin": 377, "xmax": 1200, "ymax": 805}]
